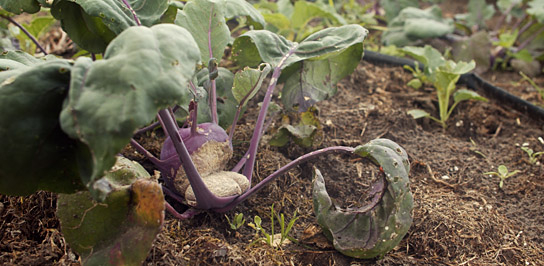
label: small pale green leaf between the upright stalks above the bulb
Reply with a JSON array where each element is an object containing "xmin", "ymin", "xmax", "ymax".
[{"xmin": 232, "ymin": 64, "xmax": 271, "ymax": 106}]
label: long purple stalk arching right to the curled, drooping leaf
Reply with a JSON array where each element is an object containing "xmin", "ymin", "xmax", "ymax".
[{"xmin": 214, "ymin": 146, "xmax": 355, "ymax": 212}]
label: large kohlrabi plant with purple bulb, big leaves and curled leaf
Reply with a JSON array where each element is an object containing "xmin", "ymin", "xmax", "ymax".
[{"xmin": 0, "ymin": 0, "xmax": 413, "ymax": 264}]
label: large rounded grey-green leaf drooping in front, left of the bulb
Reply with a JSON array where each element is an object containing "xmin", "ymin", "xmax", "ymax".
[{"xmin": 60, "ymin": 24, "xmax": 200, "ymax": 200}]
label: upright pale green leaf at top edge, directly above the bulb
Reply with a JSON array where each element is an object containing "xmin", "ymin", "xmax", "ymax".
[{"xmin": 175, "ymin": 0, "xmax": 264, "ymax": 65}]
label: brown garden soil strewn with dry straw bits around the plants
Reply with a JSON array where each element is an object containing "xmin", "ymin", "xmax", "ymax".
[{"xmin": 0, "ymin": 59, "xmax": 544, "ymax": 265}]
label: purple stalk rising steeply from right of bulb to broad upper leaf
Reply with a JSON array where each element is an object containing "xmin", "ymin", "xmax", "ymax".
[{"xmin": 242, "ymin": 46, "xmax": 297, "ymax": 185}]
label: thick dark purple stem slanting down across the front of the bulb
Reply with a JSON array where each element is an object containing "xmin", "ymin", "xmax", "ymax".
[{"xmin": 159, "ymin": 109, "xmax": 235, "ymax": 210}]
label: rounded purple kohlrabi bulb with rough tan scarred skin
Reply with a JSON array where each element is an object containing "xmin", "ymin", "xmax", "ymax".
[{"xmin": 160, "ymin": 123, "xmax": 232, "ymax": 195}]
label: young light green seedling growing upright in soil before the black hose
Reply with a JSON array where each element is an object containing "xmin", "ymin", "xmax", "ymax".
[{"xmin": 403, "ymin": 45, "xmax": 487, "ymax": 128}]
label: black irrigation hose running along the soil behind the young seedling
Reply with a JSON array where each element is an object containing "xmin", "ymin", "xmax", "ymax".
[{"xmin": 363, "ymin": 51, "xmax": 544, "ymax": 120}]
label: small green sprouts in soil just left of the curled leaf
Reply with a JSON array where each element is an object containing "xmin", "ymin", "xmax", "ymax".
[{"xmin": 248, "ymin": 204, "xmax": 299, "ymax": 248}]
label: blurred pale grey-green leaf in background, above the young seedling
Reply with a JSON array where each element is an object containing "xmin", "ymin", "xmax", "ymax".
[{"xmin": 382, "ymin": 6, "xmax": 454, "ymax": 46}]
